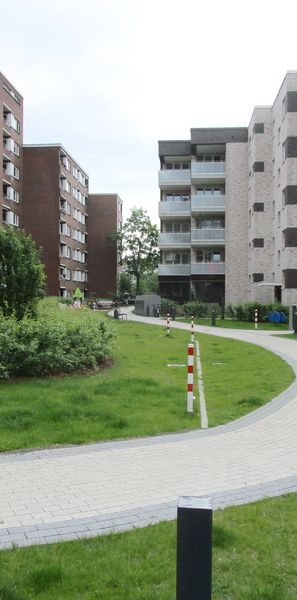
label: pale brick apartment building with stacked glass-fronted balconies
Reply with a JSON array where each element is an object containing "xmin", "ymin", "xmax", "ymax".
[{"xmin": 159, "ymin": 72, "xmax": 297, "ymax": 305}]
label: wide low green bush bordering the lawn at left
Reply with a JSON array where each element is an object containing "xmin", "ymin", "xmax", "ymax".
[{"xmin": 0, "ymin": 310, "xmax": 114, "ymax": 379}]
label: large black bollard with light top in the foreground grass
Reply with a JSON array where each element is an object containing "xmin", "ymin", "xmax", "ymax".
[{"xmin": 176, "ymin": 496, "xmax": 212, "ymax": 600}]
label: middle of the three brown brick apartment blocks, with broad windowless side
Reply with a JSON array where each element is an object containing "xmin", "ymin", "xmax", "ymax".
[{"xmin": 23, "ymin": 144, "xmax": 89, "ymax": 297}]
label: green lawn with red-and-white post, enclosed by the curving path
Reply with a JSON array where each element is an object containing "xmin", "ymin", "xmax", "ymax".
[{"xmin": 0, "ymin": 315, "xmax": 294, "ymax": 451}]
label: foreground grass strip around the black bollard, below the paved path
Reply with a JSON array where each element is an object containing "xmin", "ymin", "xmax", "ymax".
[{"xmin": 0, "ymin": 494, "xmax": 297, "ymax": 600}]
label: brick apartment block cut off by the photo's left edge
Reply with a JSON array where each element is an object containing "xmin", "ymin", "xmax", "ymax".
[{"xmin": 0, "ymin": 73, "xmax": 23, "ymax": 227}]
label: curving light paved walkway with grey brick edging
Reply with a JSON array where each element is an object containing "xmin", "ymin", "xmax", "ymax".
[{"xmin": 0, "ymin": 313, "xmax": 297, "ymax": 548}]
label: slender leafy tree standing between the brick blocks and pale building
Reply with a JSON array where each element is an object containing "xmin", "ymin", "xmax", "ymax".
[{"xmin": 115, "ymin": 208, "xmax": 159, "ymax": 294}]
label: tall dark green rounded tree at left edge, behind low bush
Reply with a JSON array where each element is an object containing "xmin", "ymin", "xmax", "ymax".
[{"xmin": 0, "ymin": 227, "xmax": 45, "ymax": 319}]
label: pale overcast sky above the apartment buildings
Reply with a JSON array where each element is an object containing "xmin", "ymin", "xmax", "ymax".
[{"xmin": 0, "ymin": 0, "xmax": 297, "ymax": 223}]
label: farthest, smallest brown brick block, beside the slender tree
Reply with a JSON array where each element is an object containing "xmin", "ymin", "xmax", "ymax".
[{"xmin": 88, "ymin": 194, "xmax": 123, "ymax": 298}]
